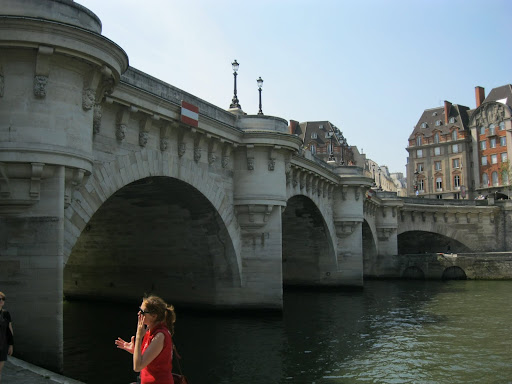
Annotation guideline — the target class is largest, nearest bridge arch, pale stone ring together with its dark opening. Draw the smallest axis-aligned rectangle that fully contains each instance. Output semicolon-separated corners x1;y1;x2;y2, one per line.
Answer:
64;150;241;304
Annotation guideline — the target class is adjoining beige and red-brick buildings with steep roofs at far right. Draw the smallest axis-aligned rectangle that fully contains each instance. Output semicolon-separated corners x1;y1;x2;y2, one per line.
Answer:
406;85;512;199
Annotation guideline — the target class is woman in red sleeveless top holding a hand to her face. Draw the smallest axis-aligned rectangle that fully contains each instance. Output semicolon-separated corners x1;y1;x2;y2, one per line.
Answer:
115;296;176;384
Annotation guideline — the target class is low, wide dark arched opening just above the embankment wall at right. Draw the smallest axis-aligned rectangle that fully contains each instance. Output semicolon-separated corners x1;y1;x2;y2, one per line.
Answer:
397;231;471;255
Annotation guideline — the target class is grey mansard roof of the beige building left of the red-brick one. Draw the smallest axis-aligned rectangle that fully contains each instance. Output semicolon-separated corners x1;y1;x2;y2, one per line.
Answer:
409;102;469;140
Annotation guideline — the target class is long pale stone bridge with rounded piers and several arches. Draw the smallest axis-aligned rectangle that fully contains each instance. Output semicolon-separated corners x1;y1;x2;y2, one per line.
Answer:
0;0;510;370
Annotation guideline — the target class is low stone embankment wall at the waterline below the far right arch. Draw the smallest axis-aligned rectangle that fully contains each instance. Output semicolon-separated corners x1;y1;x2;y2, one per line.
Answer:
365;252;512;280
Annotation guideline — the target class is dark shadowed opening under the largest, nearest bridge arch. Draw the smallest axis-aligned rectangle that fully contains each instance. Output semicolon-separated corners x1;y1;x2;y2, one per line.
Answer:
64;176;240;305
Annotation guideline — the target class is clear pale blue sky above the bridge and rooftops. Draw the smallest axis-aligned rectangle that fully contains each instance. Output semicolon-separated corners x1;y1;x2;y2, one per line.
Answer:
75;0;512;176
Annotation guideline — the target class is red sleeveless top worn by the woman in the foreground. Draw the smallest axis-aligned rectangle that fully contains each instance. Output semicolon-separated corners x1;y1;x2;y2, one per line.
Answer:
140;323;174;384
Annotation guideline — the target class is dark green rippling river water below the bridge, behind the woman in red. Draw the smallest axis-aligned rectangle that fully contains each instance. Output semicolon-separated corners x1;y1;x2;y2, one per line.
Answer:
64;281;512;384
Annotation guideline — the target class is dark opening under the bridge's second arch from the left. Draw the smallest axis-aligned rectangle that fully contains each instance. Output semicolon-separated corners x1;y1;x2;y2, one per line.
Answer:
282;195;337;286
